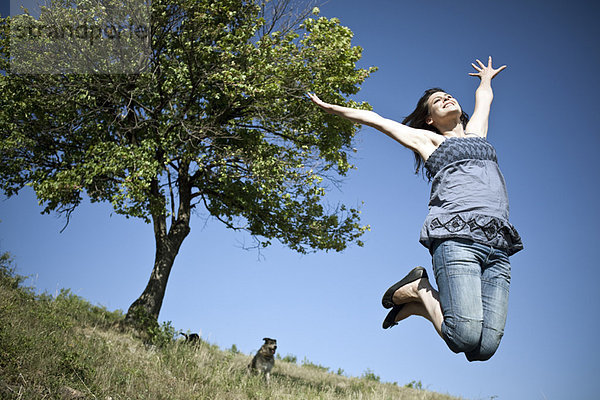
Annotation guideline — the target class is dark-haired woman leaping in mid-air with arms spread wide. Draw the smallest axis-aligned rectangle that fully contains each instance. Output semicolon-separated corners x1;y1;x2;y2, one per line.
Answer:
309;57;523;361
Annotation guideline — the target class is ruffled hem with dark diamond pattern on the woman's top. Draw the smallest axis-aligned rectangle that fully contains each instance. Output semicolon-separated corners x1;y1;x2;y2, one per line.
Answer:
419;213;523;255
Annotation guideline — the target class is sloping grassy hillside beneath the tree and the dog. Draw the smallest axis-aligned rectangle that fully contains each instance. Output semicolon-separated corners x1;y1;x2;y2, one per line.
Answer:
0;254;456;400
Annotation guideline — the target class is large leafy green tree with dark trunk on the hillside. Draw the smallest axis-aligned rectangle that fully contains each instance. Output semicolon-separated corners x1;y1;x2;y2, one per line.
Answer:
0;0;375;322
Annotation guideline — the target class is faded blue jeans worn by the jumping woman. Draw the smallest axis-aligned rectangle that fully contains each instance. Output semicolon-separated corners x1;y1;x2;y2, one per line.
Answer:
431;239;510;361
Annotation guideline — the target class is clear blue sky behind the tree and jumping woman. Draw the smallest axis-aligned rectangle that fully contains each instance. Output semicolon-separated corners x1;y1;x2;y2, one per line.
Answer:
0;0;600;400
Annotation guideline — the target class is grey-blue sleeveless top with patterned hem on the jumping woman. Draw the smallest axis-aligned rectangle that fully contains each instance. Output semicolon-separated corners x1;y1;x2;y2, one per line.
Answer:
419;137;523;255
